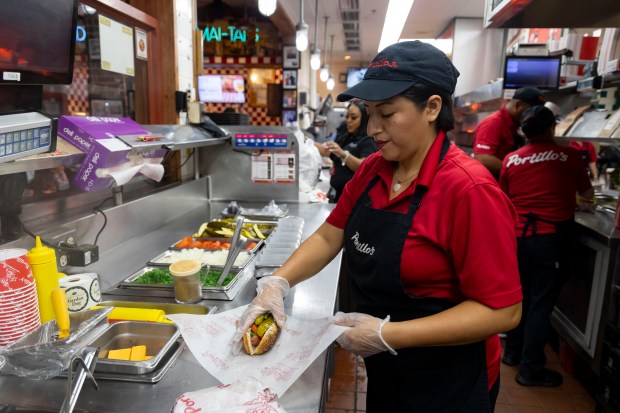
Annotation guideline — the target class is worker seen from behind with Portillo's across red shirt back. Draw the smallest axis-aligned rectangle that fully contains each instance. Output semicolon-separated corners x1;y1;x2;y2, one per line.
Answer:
500;106;594;387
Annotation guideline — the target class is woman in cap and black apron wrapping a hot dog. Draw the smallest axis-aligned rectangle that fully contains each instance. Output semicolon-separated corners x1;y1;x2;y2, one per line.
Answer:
233;41;521;413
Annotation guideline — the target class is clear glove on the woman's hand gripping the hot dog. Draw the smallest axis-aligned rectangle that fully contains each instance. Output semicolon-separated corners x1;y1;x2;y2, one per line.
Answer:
231;275;291;354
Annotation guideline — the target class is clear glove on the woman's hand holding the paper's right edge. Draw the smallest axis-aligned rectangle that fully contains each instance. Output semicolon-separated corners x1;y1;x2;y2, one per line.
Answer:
332;312;396;357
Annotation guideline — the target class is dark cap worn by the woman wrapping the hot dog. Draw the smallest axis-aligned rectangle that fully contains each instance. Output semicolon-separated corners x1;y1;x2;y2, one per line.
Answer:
338;40;459;102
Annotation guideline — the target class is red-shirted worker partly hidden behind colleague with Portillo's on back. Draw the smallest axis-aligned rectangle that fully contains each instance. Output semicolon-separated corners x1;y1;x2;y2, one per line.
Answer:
474;86;545;178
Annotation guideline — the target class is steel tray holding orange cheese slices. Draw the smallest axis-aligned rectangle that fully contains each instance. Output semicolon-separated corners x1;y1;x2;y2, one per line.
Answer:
90;321;181;375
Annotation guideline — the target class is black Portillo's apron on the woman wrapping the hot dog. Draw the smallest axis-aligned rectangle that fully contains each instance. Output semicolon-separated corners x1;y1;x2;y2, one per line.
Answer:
344;138;491;413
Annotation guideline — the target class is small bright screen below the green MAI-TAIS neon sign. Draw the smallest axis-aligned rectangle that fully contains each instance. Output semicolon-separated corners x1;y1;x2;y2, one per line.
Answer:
198;75;245;103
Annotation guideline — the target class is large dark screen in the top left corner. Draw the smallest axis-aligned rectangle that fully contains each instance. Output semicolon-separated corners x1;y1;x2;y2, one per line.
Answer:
0;0;78;85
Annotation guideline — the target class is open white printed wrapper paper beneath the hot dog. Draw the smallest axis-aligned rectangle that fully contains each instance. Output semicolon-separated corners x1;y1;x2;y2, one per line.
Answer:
166;305;349;396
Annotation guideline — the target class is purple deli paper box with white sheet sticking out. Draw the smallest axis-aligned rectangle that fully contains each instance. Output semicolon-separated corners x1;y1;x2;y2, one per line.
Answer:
58;116;166;192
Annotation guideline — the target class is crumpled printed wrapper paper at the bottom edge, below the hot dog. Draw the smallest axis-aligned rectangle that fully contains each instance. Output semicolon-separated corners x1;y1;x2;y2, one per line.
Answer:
172;379;286;413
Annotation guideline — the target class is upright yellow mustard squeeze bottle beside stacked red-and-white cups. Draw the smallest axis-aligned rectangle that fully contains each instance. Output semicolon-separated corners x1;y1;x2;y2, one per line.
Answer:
28;236;60;324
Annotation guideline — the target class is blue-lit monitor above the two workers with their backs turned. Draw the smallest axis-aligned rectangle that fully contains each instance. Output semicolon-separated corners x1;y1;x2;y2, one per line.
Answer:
504;56;562;90
